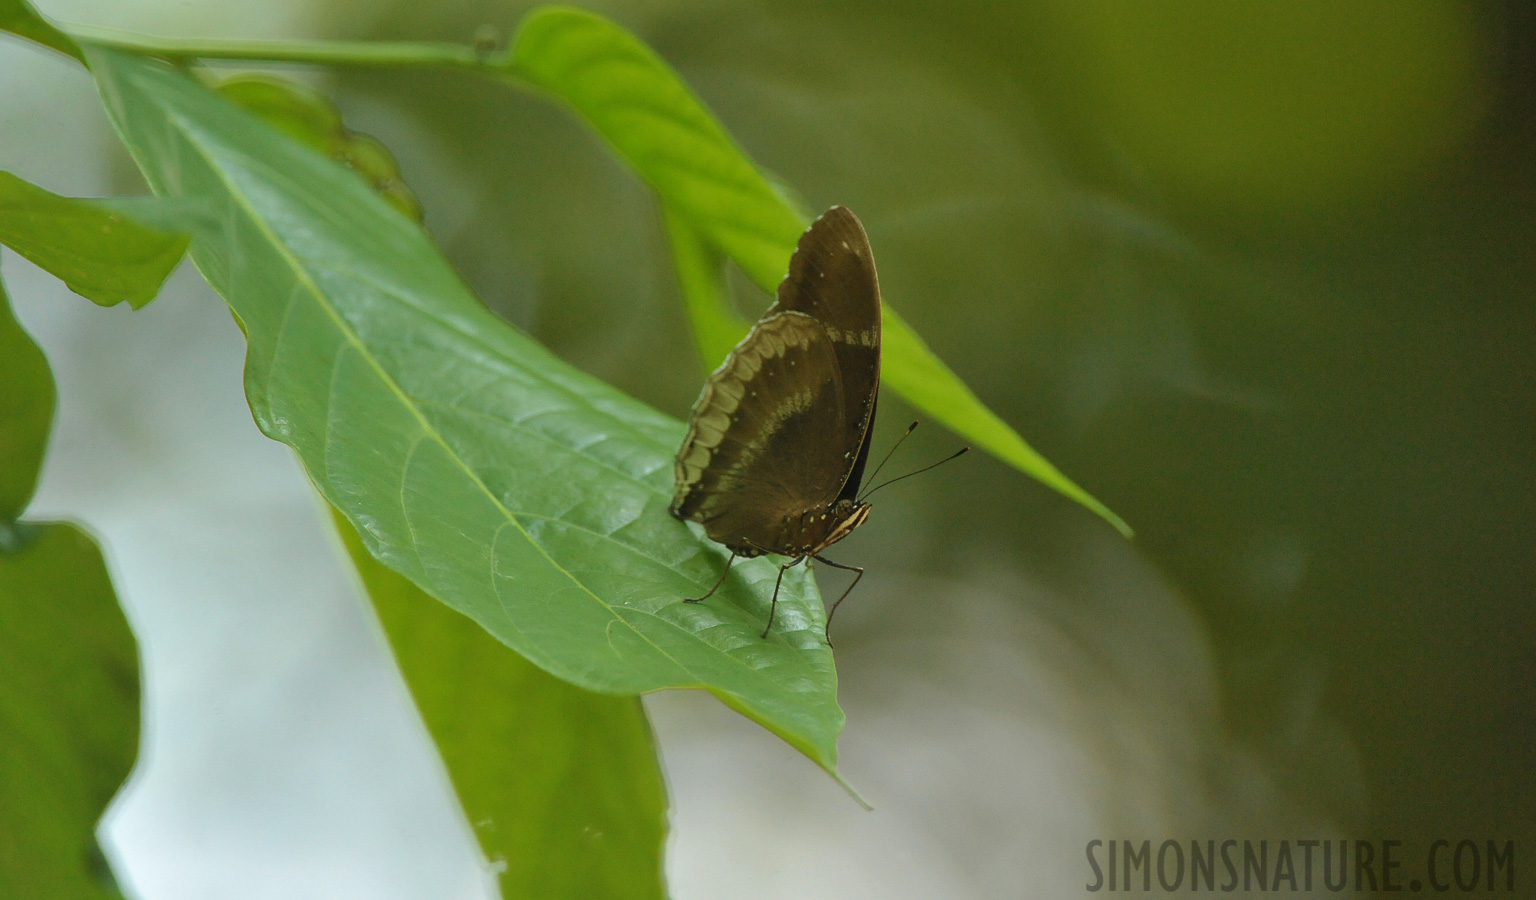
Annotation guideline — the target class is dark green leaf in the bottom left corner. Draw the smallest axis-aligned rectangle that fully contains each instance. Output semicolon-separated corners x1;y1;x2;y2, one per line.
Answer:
0;522;138;900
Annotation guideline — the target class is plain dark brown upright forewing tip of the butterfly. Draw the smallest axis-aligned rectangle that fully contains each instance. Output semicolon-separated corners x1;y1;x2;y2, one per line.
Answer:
766;206;880;499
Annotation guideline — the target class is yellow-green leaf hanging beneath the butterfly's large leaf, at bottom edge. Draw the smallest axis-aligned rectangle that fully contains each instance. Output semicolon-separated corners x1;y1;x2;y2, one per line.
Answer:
336;515;667;900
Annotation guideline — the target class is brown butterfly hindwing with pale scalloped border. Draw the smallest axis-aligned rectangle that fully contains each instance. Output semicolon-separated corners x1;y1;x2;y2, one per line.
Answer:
671;312;849;553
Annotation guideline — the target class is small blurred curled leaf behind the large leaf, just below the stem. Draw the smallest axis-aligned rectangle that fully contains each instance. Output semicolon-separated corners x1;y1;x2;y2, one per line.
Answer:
214;75;421;221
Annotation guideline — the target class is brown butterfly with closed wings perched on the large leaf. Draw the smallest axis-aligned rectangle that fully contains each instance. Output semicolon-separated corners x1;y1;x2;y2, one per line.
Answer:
671;206;880;637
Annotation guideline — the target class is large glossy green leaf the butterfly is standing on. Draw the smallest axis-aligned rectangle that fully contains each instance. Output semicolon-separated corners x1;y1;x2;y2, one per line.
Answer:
86;48;843;771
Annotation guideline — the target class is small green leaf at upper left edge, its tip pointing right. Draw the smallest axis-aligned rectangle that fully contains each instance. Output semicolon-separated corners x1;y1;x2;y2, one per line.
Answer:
0;172;187;309
